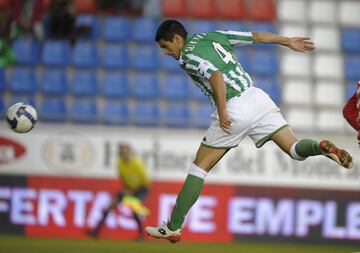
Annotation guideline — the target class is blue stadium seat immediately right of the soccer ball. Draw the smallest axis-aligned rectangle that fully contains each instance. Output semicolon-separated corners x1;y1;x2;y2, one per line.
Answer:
39;97;67;122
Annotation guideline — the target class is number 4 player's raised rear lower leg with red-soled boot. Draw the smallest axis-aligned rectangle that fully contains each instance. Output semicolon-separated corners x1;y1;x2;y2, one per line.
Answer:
272;127;352;168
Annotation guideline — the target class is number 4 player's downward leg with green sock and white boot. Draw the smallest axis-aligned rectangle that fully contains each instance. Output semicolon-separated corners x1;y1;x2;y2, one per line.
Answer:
145;145;229;242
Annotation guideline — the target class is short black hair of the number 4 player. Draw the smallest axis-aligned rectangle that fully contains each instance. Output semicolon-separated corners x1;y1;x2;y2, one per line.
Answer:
155;19;188;42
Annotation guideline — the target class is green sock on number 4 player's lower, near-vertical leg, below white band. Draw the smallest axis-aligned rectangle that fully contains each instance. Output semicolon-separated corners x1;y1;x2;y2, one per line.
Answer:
167;174;204;231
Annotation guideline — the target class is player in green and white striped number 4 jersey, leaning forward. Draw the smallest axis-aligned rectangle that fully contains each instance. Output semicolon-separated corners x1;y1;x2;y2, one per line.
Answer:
145;20;352;242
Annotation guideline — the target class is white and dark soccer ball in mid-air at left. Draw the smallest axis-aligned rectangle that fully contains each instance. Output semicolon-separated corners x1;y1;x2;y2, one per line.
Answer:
6;103;37;133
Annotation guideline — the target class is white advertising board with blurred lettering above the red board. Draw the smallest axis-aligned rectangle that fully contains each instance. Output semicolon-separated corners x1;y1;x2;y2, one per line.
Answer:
0;124;360;190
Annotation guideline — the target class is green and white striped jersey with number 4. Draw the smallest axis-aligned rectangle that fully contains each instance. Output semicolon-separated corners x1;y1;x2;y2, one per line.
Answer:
179;30;253;105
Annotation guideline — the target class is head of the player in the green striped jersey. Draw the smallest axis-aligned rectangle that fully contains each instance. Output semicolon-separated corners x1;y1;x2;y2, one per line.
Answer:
155;19;188;60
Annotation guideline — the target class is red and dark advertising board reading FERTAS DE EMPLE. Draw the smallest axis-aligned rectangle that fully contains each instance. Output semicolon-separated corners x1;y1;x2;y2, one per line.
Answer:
0;176;360;242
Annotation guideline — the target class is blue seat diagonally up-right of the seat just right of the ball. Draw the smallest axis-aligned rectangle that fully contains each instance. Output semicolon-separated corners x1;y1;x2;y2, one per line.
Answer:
70;70;98;96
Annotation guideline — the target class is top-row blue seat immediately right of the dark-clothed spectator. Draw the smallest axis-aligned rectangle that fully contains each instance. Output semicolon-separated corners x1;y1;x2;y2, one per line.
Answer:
103;16;130;42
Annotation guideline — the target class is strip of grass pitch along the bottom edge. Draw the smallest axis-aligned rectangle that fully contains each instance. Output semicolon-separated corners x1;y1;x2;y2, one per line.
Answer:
0;236;360;253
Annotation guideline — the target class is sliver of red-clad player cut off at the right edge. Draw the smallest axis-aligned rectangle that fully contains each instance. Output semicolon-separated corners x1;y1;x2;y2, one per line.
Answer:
343;81;360;146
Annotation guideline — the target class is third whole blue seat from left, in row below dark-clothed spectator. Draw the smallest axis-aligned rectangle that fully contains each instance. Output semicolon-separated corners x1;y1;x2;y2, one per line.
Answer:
72;41;98;68
